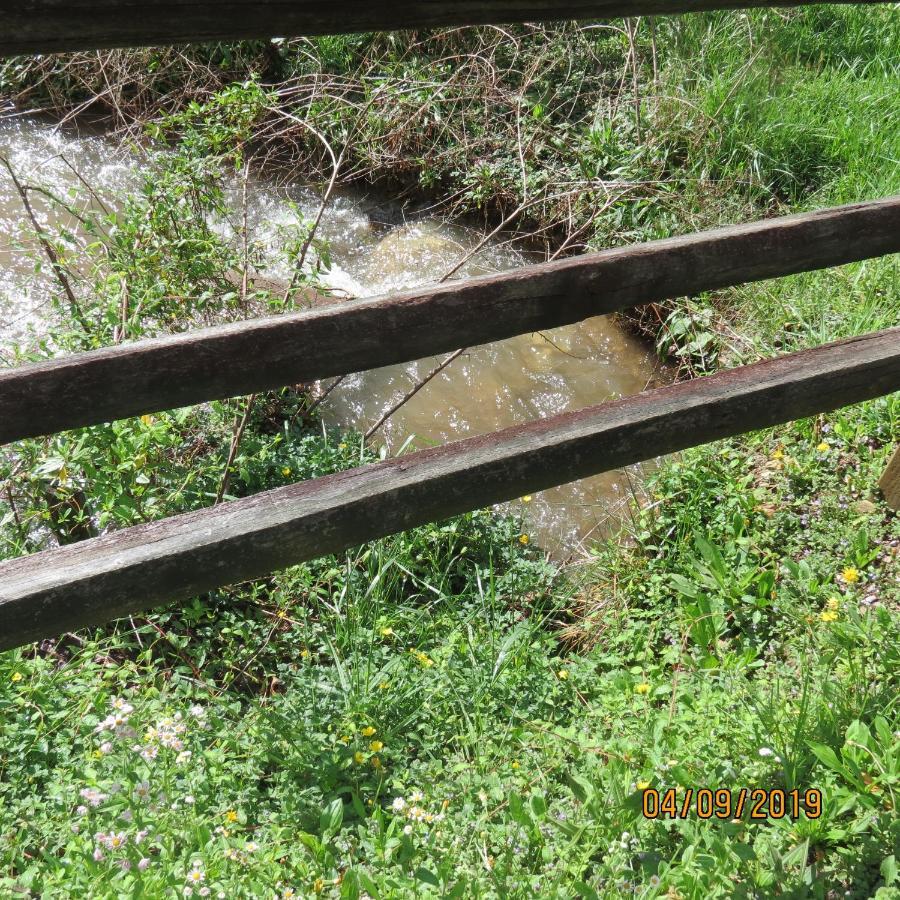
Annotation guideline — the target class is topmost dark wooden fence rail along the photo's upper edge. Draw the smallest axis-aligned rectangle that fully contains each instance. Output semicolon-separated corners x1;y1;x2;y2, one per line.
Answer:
0;0;887;55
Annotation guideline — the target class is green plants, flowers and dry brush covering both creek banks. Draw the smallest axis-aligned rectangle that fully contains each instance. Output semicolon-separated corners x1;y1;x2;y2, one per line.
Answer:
0;6;900;898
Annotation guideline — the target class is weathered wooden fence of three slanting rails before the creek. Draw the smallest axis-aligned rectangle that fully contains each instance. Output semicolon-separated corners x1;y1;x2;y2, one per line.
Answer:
0;0;900;650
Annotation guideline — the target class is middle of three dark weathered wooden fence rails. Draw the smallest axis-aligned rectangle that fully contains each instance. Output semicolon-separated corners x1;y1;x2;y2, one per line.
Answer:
0;196;900;443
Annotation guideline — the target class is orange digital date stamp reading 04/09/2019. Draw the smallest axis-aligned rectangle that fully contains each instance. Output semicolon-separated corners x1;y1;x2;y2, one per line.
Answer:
643;788;822;821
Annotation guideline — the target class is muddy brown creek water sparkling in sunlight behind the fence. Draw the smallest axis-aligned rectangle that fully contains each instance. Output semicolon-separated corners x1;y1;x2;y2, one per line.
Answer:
0;117;660;556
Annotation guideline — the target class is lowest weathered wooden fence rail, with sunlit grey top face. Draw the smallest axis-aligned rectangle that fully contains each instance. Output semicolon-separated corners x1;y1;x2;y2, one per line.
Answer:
0;328;900;650
